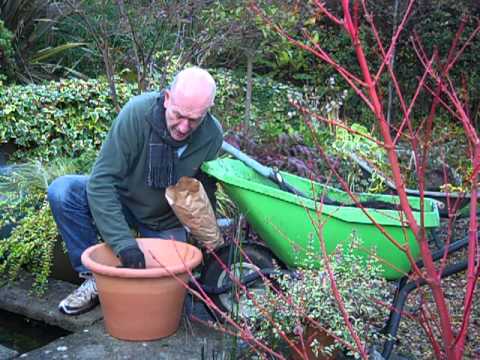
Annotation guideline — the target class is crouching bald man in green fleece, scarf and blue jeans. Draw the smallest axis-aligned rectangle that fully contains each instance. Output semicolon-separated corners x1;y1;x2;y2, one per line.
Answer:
48;67;222;315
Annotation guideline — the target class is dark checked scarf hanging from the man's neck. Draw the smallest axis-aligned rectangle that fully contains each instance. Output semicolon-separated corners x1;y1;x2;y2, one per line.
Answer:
145;93;191;189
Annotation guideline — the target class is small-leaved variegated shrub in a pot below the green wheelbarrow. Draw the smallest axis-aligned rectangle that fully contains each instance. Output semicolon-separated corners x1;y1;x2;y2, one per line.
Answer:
244;237;390;359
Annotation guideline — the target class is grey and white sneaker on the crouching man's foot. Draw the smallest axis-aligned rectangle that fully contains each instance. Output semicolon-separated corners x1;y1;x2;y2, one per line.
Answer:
58;275;99;315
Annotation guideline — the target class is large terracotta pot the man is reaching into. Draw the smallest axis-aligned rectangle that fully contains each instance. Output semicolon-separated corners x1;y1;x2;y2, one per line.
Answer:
82;238;202;341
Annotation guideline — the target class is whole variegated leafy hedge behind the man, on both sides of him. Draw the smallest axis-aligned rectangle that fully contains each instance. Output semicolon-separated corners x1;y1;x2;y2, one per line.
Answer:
0;69;316;160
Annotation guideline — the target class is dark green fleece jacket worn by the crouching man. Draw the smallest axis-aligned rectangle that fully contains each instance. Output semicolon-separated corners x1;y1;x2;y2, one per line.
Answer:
87;92;223;254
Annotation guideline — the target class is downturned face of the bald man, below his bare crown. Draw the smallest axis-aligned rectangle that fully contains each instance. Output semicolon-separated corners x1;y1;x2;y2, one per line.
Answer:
164;90;209;141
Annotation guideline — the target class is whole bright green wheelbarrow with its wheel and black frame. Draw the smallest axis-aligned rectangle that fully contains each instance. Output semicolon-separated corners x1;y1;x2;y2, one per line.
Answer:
189;145;468;359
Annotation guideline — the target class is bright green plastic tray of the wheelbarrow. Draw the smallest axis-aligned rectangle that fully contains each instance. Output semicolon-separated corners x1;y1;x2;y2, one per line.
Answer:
202;159;440;279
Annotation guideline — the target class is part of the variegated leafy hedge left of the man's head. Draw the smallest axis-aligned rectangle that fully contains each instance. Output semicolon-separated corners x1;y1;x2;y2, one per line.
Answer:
0;80;133;160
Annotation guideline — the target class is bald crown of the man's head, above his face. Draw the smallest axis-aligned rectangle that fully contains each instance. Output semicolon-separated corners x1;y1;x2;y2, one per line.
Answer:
170;66;216;107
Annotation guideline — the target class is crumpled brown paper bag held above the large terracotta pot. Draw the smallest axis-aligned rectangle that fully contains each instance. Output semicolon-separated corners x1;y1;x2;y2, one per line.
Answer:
165;176;224;251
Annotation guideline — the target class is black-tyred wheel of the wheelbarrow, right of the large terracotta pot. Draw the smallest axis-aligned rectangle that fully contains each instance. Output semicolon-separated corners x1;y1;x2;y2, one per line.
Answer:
201;244;278;316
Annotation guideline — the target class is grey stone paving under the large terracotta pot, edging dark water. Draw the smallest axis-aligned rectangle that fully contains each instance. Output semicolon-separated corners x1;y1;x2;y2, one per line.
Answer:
0;275;228;360
